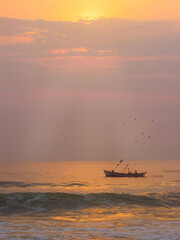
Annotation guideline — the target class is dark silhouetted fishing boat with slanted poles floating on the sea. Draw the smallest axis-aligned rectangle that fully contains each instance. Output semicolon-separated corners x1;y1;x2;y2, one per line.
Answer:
104;160;146;178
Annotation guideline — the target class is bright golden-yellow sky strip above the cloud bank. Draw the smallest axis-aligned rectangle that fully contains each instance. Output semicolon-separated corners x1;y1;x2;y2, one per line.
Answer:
0;0;180;21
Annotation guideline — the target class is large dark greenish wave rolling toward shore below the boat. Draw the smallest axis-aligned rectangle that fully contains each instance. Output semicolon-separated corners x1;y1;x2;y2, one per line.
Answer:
0;192;180;214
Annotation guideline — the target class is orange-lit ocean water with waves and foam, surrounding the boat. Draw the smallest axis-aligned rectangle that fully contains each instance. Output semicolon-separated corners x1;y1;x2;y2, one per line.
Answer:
0;161;180;240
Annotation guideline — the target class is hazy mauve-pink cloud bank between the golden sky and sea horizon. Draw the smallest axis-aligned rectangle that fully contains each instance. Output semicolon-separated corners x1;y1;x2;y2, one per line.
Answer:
0;18;180;160
